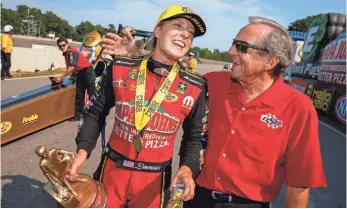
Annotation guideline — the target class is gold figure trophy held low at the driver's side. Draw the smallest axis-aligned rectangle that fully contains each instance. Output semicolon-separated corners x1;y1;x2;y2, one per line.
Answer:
35;146;107;208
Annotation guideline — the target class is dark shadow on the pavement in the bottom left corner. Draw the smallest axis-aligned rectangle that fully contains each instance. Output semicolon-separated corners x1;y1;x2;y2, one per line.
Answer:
1;175;57;208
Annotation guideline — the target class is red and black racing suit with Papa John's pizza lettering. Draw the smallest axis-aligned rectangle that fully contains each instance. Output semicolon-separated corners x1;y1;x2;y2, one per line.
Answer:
76;57;207;208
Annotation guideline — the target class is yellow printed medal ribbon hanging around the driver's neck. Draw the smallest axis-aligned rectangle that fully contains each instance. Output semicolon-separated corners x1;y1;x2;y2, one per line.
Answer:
135;54;179;131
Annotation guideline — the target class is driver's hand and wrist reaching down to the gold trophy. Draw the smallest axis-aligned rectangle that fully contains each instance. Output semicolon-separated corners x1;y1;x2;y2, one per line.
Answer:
65;149;88;182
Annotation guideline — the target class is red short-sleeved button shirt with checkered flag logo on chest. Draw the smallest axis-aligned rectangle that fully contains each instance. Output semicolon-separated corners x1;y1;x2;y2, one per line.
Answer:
197;72;327;202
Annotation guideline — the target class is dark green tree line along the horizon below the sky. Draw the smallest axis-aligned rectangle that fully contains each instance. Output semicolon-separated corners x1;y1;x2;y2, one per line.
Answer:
1;5;315;62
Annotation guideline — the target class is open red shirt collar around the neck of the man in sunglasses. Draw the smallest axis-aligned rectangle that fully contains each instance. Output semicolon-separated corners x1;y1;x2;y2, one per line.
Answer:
228;76;288;107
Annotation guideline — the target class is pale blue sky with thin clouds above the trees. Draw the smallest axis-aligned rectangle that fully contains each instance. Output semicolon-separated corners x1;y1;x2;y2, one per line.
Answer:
2;0;346;51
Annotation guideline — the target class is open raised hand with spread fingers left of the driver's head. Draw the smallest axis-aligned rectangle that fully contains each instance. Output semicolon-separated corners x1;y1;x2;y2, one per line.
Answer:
101;27;138;56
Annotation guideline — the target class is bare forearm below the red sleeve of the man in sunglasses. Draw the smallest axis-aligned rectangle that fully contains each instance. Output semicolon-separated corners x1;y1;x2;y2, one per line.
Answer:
285;186;310;208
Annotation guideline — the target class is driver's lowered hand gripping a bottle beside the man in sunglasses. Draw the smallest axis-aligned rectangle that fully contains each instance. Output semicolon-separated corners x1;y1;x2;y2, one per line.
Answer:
170;166;195;201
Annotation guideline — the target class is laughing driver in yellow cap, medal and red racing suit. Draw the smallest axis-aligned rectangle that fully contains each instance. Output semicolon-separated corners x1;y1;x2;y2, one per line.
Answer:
67;5;208;208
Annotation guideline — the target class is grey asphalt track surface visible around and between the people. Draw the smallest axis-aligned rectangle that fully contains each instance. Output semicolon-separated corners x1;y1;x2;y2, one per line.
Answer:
1;65;346;208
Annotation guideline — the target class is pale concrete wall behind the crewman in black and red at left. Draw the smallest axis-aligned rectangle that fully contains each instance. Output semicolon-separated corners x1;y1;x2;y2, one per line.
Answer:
11;47;66;72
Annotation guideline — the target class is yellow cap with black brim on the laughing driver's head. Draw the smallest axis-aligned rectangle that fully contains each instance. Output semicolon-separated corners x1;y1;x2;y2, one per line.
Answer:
156;5;206;37
